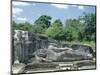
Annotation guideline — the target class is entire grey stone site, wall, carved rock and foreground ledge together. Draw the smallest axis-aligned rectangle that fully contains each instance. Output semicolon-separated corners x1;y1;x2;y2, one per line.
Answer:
12;30;95;74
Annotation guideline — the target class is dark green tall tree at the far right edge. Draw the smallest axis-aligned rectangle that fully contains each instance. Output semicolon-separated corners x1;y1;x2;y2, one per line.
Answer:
80;13;96;41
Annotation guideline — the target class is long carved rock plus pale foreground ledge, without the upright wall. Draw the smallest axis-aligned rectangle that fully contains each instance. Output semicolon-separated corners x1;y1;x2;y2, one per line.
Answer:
12;45;96;73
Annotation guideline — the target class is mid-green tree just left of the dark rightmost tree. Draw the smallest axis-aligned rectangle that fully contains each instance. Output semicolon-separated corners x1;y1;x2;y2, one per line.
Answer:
65;19;82;41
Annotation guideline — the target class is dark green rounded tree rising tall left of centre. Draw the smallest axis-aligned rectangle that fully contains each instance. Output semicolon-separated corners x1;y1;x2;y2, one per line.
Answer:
34;15;51;33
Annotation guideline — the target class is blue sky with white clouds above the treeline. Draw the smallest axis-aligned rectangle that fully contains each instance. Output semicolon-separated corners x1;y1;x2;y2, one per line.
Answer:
12;1;95;24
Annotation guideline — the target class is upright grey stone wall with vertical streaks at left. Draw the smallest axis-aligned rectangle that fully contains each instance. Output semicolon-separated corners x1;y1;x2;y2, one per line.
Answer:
12;30;48;63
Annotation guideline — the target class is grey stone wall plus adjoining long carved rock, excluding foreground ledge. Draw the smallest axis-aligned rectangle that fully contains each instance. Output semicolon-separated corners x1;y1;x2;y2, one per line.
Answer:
13;30;93;63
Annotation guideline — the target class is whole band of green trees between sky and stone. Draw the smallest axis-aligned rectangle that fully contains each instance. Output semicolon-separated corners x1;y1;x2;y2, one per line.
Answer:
12;13;96;42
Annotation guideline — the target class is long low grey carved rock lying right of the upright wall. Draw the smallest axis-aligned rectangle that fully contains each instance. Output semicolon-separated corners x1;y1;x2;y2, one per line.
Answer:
34;45;93;62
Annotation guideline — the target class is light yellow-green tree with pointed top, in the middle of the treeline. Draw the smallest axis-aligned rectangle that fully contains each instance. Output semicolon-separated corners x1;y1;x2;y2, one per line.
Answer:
46;20;66;41
